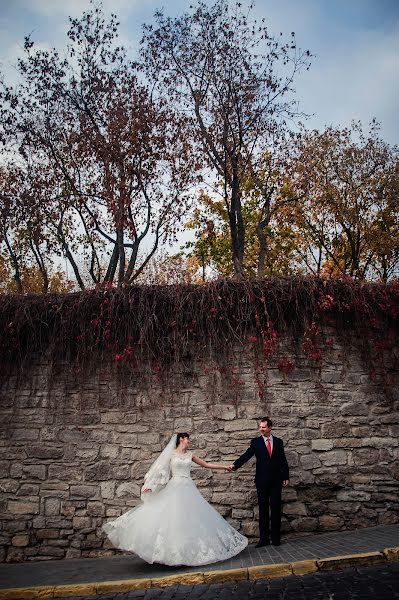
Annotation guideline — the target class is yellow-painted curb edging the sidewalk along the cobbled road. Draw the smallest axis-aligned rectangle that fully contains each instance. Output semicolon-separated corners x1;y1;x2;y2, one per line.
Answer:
0;547;399;600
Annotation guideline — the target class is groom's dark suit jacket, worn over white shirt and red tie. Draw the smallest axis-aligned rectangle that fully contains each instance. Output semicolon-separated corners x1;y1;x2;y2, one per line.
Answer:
233;435;289;487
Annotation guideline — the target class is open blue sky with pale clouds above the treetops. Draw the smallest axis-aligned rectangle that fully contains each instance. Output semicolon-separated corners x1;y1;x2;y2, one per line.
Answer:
0;0;399;144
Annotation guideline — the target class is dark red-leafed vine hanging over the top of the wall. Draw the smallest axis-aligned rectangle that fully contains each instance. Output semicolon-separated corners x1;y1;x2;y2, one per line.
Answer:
0;278;399;397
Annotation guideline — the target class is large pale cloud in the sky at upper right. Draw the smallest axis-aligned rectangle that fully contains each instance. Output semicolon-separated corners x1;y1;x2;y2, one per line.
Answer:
297;17;399;143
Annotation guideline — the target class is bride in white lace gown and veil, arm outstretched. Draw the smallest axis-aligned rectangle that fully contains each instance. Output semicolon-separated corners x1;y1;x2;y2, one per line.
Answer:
102;433;248;566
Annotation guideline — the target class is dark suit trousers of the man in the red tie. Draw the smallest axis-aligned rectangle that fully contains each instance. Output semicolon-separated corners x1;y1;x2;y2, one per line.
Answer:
256;481;282;542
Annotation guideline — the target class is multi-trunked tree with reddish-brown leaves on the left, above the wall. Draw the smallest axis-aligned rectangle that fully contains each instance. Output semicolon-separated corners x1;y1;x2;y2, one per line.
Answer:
0;5;195;288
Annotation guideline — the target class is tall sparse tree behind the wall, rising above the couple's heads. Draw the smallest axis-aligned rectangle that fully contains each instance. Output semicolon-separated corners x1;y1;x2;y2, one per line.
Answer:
142;0;310;276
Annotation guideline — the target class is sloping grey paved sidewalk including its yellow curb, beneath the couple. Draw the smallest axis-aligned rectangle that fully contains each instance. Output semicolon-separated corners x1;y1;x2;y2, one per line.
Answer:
0;524;399;598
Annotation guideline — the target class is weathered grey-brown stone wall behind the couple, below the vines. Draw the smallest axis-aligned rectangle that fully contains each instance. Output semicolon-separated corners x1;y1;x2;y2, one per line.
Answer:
0;338;399;561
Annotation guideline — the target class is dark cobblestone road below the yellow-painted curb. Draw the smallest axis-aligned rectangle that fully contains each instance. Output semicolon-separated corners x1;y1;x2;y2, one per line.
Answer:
55;562;399;600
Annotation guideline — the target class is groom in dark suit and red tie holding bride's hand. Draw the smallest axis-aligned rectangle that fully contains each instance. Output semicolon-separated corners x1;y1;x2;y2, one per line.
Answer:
229;417;289;548
